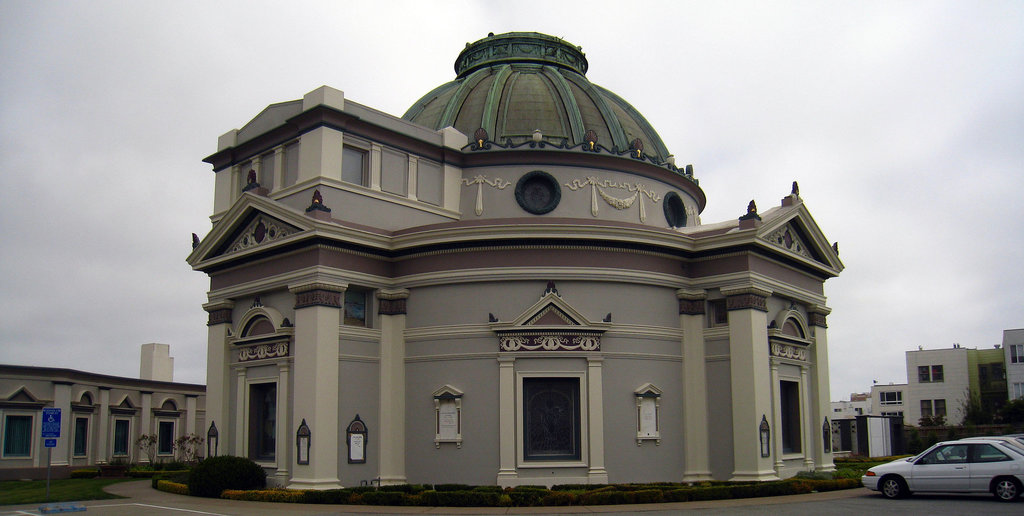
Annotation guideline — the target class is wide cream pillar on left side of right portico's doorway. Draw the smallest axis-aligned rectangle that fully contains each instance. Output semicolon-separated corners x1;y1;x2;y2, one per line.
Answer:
722;287;779;481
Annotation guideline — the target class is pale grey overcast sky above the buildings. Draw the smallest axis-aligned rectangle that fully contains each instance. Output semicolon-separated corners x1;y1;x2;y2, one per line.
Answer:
0;0;1024;399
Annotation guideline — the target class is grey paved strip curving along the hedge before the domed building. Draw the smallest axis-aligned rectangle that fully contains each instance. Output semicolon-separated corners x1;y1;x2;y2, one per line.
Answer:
0;480;870;516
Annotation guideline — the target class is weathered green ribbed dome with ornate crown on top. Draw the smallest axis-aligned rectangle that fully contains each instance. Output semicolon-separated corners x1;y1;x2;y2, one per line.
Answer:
402;33;669;163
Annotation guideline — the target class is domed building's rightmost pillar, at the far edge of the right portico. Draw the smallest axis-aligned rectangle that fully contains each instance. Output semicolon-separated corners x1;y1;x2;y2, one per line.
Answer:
808;305;836;471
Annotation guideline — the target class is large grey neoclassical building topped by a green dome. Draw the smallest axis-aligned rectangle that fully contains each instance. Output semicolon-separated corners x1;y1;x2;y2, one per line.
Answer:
188;33;843;488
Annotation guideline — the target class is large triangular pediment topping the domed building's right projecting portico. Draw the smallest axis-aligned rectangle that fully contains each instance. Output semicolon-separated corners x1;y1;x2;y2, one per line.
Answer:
757;202;844;274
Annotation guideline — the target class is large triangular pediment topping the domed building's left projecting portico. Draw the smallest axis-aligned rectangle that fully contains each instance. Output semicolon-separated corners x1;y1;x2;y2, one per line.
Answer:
187;194;314;267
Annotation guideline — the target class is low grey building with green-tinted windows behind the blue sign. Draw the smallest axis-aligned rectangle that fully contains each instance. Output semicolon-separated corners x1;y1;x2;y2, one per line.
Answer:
0;344;206;479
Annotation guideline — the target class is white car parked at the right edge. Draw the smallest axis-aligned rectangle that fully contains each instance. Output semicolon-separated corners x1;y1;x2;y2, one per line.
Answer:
860;439;1024;502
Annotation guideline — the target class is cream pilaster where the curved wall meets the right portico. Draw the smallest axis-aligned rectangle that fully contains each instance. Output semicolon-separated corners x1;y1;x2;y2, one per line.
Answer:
676;290;712;482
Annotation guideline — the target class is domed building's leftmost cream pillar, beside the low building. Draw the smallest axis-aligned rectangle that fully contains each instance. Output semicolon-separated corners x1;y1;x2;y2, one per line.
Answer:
200;299;232;455
